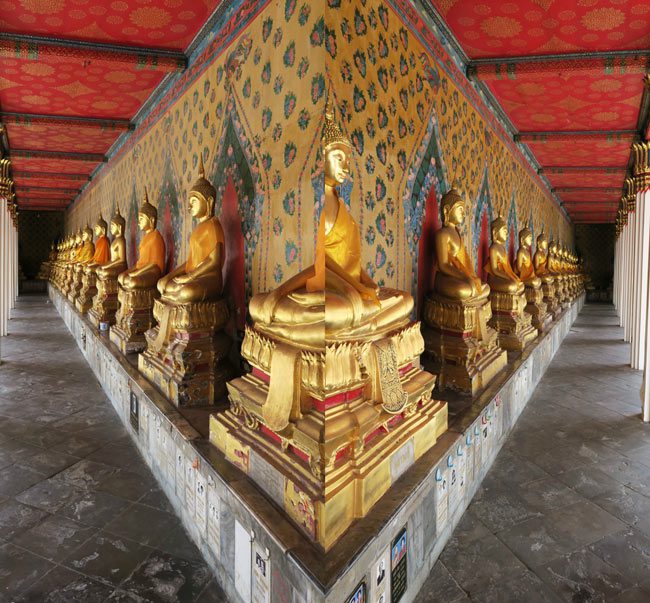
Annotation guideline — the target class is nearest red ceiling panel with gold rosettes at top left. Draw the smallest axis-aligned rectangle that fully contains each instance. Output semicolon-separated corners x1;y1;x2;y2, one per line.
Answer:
0;0;219;50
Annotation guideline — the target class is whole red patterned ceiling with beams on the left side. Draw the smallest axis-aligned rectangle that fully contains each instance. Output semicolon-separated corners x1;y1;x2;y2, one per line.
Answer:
0;0;223;207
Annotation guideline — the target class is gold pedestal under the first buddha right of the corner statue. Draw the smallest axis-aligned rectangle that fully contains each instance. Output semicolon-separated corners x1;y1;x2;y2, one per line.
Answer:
422;293;508;395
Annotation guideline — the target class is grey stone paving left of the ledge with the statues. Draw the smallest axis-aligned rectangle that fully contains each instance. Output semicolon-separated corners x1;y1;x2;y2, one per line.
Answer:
0;296;226;603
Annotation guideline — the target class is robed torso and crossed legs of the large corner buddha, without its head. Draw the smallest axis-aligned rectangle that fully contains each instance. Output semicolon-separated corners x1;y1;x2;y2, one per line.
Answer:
249;199;413;347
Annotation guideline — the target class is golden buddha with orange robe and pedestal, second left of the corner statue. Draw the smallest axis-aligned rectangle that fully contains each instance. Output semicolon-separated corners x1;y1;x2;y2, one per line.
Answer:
110;189;165;354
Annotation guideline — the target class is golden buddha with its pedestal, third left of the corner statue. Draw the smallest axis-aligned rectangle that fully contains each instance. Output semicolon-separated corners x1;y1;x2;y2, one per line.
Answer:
88;206;128;331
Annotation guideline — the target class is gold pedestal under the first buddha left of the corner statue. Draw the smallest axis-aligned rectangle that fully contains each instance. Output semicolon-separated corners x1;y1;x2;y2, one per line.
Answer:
138;299;232;406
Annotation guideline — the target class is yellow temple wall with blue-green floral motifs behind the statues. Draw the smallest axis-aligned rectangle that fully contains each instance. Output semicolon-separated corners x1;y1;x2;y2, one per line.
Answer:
66;0;573;316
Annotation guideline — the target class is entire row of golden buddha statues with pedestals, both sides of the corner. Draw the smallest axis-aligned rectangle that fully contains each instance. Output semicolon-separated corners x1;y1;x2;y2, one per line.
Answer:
45;105;581;550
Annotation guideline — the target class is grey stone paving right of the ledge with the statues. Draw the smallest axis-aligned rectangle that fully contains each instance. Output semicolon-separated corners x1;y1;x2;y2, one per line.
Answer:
416;304;650;603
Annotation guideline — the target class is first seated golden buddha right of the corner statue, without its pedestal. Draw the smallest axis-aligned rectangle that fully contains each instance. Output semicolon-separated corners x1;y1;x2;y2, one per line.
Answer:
433;188;490;301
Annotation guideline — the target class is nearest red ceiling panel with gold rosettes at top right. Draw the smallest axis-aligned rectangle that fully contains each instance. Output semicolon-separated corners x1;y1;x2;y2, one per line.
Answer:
433;0;650;58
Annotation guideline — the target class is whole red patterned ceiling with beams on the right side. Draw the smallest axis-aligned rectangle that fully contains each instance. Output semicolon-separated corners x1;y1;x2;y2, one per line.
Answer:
433;0;650;222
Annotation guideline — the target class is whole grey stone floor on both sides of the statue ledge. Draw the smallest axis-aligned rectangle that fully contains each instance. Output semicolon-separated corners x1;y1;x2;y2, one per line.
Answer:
0;297;650;603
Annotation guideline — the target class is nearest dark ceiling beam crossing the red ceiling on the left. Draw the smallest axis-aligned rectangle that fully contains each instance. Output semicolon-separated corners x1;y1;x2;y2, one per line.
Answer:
0;33;187;73
